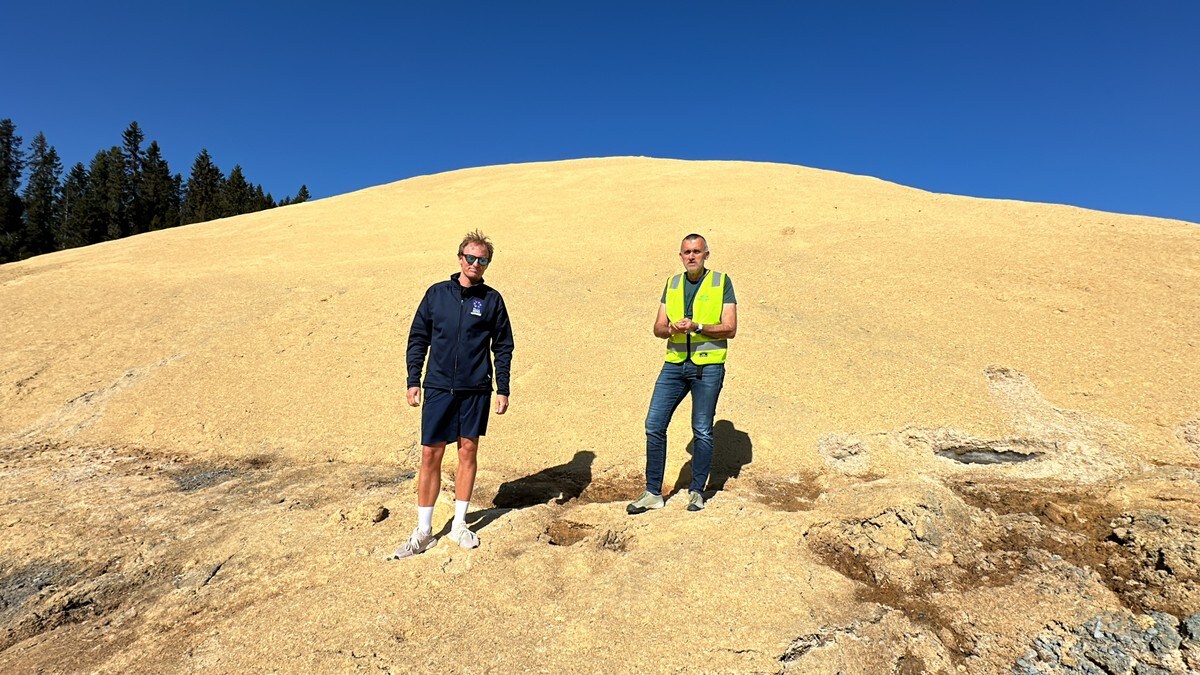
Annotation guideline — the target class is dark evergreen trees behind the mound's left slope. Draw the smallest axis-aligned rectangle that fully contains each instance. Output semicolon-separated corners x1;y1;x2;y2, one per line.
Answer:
0;119;308;263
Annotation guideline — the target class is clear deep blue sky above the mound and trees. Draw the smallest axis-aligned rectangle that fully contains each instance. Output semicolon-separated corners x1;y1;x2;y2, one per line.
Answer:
0;0;1200;222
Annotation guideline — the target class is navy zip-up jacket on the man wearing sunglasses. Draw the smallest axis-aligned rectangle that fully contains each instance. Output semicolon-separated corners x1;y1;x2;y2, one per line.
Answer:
408;273;512;396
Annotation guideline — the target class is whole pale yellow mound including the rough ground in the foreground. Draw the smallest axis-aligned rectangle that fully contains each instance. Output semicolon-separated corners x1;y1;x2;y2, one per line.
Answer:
0;159;1200;673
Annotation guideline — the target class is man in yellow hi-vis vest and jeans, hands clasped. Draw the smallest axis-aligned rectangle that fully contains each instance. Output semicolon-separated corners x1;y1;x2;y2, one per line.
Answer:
625;234;738;514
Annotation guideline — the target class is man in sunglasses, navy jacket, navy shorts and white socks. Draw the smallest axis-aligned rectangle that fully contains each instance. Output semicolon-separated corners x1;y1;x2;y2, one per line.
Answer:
394;231;512;557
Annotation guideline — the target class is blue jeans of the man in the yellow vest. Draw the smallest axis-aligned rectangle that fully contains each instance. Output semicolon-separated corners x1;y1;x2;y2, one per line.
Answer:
646;362;725;495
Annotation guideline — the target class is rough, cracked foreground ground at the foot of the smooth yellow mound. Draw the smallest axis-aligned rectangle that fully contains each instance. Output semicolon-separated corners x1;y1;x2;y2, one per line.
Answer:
0;427;1200;673
